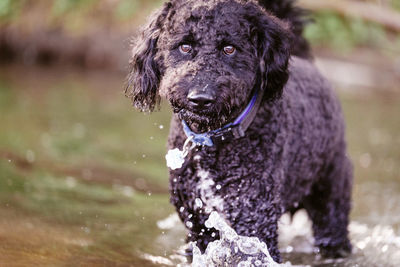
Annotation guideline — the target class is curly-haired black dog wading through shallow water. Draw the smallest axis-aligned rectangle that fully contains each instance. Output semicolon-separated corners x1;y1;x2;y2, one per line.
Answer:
126;0;352;262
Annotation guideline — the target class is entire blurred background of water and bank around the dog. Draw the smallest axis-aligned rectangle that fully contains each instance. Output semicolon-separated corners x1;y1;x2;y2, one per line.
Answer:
0;0;400;266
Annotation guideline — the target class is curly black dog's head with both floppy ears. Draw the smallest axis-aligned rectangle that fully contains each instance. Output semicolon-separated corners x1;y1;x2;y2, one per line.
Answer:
126;0;290;132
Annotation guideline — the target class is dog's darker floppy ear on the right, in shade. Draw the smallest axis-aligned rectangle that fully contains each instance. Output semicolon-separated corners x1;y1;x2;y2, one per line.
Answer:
255;15;290;99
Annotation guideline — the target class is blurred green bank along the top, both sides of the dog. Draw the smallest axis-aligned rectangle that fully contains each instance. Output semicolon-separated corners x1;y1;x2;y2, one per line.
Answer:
0;0;400;56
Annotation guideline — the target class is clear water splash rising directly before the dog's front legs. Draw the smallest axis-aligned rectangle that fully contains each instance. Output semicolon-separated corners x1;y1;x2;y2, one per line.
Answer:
191;211;293;267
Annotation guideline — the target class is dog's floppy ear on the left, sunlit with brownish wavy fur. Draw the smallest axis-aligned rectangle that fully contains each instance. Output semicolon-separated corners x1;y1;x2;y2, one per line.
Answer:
125;3;171;111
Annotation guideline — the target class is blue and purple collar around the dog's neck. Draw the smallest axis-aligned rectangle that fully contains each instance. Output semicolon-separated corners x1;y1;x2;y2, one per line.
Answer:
182;86;263;147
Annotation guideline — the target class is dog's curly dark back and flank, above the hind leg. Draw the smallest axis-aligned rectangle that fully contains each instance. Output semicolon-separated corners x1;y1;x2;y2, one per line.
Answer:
274;57;351;210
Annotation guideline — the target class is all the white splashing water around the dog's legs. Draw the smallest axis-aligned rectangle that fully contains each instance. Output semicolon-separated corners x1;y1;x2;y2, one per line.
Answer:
157;209;400;267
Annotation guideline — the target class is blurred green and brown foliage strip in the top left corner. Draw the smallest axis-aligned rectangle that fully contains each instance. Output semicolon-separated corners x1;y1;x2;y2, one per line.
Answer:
0;0;163;34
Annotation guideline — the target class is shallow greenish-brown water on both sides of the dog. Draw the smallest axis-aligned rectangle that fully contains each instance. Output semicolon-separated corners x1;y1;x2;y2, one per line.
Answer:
0;66;400;266
